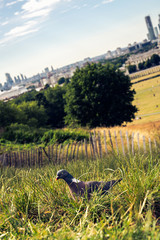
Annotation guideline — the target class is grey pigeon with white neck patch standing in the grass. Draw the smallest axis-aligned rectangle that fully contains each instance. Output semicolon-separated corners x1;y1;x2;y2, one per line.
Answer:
56;169;122;200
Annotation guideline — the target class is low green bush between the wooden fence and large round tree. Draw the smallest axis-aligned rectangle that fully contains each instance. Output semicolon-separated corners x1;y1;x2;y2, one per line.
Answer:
41;129;89;144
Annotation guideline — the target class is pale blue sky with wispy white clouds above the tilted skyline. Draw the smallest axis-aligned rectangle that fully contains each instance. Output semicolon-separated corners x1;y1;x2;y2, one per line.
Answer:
0;0;160;82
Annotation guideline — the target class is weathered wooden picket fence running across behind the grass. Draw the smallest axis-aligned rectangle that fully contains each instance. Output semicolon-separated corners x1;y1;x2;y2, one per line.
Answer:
0;130;159;167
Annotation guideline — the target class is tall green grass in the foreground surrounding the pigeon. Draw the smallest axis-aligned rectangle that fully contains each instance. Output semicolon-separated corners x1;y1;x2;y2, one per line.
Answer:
0;155;160;240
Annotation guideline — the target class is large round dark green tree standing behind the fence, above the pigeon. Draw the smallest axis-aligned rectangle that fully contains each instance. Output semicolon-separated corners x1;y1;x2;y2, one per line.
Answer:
65;63;137;127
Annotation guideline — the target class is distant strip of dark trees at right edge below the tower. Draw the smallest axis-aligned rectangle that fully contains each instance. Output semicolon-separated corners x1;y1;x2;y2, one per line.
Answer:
128;54;160;73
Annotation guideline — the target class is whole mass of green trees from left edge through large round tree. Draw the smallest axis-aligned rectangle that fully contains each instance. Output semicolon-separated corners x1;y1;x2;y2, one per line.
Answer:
0;63;137;142
